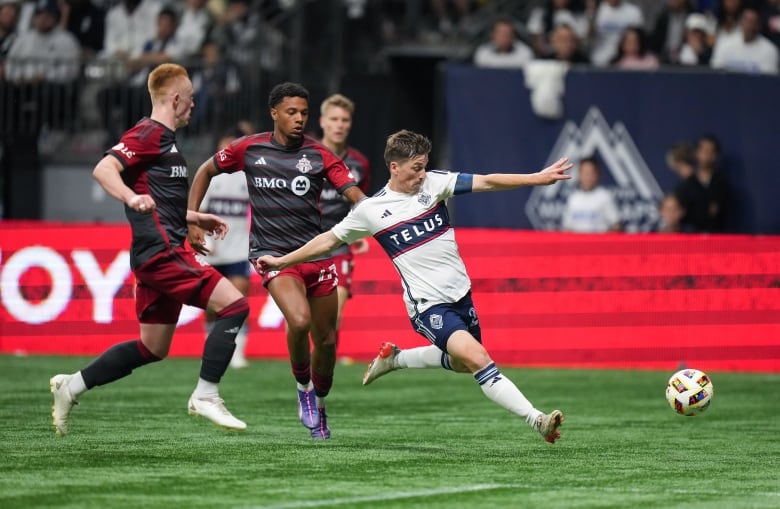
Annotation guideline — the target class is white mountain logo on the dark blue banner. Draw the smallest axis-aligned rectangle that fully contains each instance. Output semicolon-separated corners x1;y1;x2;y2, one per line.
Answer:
525;106;663;232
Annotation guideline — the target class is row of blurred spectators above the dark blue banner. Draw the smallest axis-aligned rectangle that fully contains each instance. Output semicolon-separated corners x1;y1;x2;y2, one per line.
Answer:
474;0;780;74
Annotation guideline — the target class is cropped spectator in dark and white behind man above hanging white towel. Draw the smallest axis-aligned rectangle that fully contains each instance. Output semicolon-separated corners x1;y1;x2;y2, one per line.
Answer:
526;0;588;57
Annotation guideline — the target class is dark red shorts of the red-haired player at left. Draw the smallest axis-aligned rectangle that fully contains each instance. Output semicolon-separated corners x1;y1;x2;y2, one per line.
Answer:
133;246;222;323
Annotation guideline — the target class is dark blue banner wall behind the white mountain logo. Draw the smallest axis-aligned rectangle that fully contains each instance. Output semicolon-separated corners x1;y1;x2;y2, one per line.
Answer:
445;64;780;234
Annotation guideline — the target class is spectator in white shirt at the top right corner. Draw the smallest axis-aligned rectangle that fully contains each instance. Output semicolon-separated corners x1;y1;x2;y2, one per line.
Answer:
710;8;778;74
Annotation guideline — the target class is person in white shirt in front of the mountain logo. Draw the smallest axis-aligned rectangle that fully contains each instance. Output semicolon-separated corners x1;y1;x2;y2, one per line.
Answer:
561;157;623;233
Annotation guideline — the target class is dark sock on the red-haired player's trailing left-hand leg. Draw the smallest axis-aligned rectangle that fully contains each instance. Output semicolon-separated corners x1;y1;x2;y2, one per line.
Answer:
81;339;161;389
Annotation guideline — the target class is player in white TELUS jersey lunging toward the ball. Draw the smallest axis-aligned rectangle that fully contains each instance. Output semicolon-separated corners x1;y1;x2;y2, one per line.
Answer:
257;130;572;443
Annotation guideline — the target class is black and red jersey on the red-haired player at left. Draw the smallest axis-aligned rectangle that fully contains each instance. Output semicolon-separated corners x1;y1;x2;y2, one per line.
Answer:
106;118;189;269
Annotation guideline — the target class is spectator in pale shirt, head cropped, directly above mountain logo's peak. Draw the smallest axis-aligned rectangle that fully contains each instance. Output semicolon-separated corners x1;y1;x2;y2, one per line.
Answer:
589;0;645;67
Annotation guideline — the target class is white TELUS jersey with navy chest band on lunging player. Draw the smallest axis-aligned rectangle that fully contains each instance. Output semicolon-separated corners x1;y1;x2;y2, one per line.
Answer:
331;170;471;317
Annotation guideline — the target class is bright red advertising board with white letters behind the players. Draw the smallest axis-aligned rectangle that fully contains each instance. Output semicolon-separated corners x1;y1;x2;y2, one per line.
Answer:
0;222;780;372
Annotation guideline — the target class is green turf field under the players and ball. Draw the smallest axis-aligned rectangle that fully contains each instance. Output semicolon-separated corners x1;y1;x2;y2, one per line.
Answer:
0;356;780;509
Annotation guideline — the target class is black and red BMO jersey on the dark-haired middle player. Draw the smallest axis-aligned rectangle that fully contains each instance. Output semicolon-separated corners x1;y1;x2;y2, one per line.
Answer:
214;132;356;258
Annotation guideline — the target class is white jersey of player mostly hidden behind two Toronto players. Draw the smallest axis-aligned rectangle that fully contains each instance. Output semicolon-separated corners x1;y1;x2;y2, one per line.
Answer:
200;171;249;265
